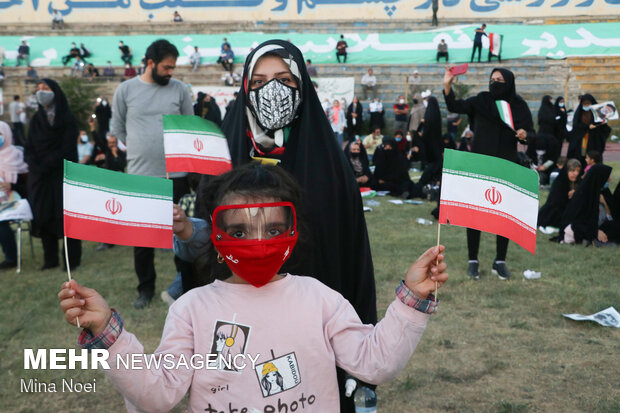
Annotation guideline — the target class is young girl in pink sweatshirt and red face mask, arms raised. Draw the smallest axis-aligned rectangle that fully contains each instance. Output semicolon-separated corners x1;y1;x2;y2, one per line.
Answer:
58;164;448;413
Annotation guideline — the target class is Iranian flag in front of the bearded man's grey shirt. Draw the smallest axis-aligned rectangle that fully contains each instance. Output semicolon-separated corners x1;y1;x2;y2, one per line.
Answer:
163;115;232;175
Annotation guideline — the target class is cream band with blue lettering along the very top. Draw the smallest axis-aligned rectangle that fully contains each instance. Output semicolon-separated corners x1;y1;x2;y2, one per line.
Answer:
0;0;618;23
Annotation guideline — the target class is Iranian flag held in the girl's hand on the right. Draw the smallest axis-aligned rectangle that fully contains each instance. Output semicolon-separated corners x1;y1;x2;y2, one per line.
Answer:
439;149;538;254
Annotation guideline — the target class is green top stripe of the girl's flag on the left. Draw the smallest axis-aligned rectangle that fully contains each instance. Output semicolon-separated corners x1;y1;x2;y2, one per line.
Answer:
64;160;172;200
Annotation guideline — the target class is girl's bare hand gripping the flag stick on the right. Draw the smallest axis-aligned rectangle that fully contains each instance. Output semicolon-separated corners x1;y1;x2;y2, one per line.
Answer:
405;245;448;300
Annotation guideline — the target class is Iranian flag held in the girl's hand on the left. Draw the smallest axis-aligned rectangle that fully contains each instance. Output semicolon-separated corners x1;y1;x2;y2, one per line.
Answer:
63;160;172;248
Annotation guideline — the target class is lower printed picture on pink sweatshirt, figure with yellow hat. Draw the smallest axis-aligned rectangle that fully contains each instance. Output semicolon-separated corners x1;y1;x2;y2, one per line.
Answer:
256;350;301;397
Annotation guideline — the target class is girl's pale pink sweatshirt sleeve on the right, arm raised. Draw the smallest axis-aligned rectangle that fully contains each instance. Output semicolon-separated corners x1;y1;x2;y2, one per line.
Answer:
324;299;429;384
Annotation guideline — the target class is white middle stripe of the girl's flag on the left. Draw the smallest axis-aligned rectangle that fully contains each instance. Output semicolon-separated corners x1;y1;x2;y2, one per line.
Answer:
63;183;172;226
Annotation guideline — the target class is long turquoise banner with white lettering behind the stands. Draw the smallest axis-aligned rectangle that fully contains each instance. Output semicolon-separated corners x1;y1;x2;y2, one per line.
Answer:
0;23;620;66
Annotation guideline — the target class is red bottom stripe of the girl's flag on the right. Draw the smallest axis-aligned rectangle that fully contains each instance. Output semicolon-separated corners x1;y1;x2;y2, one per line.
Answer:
439;201;536;254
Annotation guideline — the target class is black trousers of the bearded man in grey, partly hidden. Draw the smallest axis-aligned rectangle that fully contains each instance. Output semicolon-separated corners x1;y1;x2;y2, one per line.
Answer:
133;177;192;297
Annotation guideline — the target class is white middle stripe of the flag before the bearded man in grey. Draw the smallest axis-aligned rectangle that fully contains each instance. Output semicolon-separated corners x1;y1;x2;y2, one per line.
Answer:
164;131;230;160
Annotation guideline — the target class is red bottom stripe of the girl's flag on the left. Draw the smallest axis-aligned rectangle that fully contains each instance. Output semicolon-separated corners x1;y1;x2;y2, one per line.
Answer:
64;215;172;248
